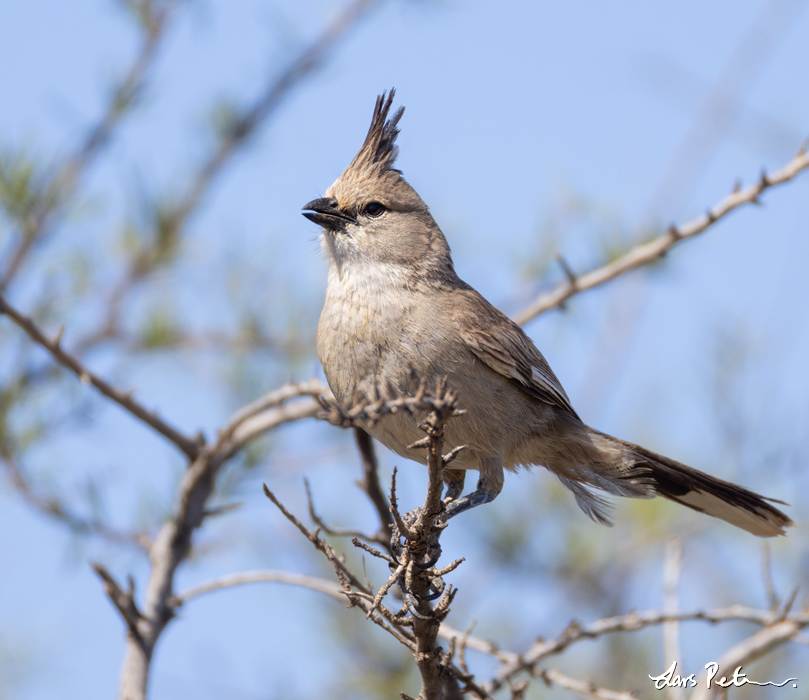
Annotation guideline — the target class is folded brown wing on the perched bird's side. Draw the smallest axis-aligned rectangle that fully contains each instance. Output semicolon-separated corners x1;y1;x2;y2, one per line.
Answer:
454;289;578;417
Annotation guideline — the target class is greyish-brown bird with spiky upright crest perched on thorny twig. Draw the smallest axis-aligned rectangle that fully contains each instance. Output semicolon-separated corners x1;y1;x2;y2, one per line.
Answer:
303;89;794;537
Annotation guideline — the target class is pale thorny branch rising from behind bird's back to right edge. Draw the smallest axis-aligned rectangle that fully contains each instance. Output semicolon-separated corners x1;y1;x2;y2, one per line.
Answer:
514;153;809;325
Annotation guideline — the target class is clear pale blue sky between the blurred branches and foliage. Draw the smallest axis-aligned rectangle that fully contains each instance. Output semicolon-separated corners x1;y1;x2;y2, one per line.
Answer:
0;0;809;700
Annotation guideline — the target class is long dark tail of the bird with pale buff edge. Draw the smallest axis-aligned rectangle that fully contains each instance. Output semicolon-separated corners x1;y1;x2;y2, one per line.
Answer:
589;428;795;537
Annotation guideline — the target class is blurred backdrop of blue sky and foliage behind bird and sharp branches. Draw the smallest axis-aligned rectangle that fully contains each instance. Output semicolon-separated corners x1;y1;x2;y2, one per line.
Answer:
0;0;809;700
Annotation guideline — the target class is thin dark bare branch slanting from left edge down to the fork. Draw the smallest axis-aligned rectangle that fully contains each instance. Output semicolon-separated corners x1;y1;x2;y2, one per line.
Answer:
0;296;202;459
